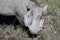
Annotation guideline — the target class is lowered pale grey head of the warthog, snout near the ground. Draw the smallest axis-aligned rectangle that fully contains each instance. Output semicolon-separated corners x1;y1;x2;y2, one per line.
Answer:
24;5;48;34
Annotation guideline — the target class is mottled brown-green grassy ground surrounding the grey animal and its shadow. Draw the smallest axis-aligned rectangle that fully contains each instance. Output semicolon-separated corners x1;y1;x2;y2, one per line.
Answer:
0;0;60;40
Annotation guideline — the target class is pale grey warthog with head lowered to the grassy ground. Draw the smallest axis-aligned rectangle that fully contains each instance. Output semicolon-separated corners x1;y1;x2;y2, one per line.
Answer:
0;0;48;34
